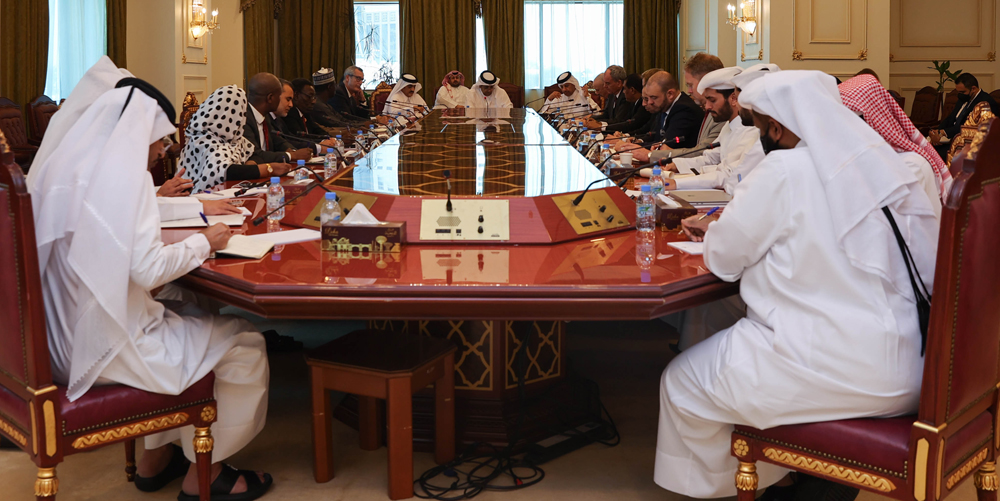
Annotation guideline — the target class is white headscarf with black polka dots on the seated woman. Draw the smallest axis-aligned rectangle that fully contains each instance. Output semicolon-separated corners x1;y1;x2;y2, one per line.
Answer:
178;85;253;191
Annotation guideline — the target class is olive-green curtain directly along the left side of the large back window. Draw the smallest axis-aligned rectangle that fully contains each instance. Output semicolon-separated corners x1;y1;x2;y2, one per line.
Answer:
482;0;524;87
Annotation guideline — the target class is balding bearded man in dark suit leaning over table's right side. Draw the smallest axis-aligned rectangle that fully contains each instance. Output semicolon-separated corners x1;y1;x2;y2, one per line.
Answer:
615;71;703;162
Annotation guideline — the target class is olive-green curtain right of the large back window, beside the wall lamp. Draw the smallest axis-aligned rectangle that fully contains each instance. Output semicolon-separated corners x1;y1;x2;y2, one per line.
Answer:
623;0;680;76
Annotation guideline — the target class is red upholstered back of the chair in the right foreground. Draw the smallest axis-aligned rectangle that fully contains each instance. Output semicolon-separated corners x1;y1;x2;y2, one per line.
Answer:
919;116;1000;430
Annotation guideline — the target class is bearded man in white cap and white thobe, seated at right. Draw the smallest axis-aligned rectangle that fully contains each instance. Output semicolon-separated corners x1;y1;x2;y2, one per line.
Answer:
649;66;764;194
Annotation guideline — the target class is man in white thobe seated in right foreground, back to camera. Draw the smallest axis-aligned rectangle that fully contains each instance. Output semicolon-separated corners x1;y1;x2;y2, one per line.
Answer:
654;71;939;498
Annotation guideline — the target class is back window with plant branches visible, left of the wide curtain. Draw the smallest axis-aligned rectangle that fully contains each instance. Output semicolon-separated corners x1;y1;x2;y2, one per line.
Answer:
352;0;400;89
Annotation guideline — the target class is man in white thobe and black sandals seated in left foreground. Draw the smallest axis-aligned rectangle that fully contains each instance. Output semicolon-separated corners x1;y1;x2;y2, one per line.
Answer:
29;72;271;500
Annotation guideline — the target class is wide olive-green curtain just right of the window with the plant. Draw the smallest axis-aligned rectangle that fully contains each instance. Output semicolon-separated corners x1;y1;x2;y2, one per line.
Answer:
397;0;474;105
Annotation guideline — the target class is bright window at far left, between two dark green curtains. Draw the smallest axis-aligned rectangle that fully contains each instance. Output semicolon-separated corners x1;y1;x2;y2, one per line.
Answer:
45;0;108;102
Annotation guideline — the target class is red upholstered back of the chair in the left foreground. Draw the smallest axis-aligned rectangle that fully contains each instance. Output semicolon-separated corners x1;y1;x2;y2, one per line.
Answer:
0;130;52;398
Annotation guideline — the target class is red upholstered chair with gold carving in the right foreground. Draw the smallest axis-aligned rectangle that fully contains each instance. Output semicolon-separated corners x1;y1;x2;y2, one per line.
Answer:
730;116;1000;501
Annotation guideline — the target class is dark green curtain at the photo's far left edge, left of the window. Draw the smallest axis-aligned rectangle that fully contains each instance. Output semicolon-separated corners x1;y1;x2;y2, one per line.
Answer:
0;0;49;108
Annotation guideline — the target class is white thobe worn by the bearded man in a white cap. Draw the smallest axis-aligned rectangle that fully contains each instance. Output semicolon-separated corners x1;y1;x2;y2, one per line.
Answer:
674;116;764;195
